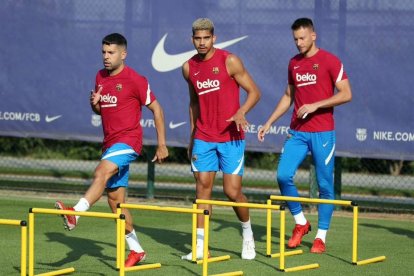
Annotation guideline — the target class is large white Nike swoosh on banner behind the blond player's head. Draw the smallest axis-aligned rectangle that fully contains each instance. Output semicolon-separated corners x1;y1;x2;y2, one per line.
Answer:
151;33;247;72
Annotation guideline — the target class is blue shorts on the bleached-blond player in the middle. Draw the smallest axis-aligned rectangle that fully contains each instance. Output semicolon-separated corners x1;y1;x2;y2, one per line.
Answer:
191;139;245;176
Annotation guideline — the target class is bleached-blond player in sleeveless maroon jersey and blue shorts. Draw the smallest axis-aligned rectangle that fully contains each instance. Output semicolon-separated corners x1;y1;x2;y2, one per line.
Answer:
182;18;260;260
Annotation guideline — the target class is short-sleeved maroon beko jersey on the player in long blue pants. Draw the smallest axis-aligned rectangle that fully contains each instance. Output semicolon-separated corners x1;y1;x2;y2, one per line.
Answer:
288;49;348;132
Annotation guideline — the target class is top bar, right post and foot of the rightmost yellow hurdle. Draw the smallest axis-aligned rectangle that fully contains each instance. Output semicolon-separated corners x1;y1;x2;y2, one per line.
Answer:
270;195;386;265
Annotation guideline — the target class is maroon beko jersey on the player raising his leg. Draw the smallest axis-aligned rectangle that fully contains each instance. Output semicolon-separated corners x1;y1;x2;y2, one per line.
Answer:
95;66;155;154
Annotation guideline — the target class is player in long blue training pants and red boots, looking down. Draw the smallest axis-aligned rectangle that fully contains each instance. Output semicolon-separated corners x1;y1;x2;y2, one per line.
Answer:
257;18;352;253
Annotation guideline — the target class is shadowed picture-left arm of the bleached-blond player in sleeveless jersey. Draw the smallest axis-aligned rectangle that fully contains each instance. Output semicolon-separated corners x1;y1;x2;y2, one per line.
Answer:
182;62;200;158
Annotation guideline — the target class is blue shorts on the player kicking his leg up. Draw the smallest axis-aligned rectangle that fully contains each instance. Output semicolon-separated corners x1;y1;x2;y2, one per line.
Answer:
101;143;138;188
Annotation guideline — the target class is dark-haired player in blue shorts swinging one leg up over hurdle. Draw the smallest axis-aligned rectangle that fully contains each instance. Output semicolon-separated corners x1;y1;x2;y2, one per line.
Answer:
55;33;168;267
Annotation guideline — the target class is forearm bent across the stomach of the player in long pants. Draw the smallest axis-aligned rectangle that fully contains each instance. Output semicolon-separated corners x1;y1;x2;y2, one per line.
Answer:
296;79;352;118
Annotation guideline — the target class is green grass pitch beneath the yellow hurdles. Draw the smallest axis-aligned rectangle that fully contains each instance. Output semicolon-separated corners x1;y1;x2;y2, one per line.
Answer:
0;194;414;275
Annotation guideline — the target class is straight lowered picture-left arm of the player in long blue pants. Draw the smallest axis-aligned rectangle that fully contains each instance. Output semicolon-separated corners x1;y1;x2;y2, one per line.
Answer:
257;85;295;142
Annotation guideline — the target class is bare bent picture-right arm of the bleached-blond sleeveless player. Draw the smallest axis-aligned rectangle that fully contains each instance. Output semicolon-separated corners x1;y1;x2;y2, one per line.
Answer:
226;55;260;130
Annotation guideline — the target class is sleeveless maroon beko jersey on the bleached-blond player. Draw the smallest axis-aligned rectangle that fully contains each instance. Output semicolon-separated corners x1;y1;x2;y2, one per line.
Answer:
188;49;244;142
